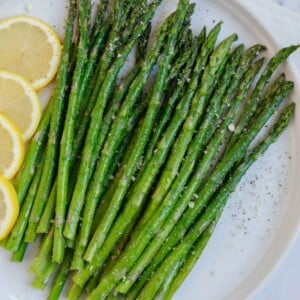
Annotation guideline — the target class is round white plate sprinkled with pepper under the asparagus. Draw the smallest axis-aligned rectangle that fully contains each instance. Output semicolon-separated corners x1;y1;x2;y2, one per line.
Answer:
0;0;300;300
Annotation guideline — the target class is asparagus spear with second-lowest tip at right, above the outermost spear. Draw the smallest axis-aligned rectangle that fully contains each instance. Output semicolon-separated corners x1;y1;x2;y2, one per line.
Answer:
133;78;293;292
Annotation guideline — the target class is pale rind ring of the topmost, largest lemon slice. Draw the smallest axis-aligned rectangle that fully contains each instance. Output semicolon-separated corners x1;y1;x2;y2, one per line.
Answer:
0;15;62;90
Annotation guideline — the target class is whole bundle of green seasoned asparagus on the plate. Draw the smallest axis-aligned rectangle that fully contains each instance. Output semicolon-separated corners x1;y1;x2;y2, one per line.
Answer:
4;0;298;300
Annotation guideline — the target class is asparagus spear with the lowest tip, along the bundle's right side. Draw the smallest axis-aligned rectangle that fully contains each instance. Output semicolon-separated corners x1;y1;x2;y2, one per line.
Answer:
139;101;294;300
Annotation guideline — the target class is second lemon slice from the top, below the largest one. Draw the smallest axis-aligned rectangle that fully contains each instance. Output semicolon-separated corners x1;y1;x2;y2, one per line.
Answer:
0;70;41;141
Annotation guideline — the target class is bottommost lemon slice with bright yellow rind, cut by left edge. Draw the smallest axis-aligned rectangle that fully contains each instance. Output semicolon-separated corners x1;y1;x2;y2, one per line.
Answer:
0;175;19;241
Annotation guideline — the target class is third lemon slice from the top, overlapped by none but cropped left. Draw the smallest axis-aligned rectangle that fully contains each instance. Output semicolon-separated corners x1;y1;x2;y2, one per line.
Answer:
0;114;25;179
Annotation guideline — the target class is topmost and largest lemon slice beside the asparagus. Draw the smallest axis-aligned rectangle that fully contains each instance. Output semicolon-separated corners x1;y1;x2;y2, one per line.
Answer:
0;16;61;89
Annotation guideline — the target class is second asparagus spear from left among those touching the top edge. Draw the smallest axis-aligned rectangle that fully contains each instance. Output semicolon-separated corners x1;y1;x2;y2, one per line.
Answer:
53;0;91;263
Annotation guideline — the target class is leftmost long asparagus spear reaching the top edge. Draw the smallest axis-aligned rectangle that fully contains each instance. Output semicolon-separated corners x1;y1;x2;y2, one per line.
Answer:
25;0;76;242
